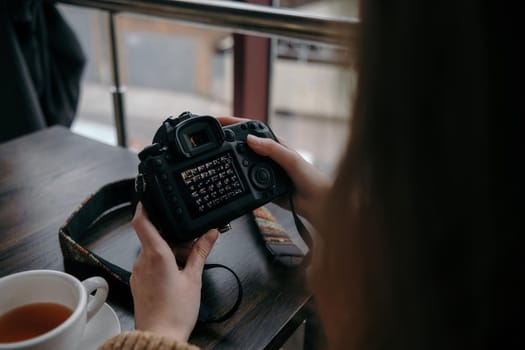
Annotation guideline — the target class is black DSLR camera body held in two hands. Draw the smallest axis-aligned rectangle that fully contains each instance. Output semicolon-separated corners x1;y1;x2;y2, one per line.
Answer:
135;112;292;242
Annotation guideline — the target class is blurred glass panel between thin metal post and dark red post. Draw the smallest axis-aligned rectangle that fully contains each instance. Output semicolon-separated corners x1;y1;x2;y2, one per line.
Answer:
117;14;233;150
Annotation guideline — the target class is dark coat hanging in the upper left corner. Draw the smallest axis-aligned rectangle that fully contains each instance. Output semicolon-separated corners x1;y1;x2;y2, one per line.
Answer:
0;0;85;142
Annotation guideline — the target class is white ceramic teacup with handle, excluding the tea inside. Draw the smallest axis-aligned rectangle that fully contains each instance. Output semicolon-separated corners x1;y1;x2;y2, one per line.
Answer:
0;270;108;350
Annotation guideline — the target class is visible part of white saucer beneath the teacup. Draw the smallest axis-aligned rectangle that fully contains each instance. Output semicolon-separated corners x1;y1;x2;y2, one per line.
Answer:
77;304;120;350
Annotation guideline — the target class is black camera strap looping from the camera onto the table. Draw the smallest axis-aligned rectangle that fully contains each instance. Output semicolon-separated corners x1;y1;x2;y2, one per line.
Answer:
59;178;313;323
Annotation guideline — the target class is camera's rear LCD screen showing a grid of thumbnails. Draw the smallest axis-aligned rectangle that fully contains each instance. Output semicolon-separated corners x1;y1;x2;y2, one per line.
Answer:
177;152;245;218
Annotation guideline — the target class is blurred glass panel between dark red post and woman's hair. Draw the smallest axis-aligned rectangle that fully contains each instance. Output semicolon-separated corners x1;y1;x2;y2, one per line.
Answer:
270;39;357;173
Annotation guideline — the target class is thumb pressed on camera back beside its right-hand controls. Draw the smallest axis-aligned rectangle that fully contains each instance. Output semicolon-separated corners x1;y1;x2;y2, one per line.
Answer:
246;135;306;180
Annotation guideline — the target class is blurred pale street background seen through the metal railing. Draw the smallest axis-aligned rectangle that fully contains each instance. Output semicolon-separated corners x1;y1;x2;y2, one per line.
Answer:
58;0;358;173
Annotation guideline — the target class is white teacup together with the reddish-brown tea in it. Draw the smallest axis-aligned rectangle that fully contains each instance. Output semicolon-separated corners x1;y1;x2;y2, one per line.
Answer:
0;270;108;350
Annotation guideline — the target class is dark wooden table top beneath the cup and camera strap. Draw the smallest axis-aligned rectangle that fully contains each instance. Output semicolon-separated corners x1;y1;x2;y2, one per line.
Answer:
0;127;316;349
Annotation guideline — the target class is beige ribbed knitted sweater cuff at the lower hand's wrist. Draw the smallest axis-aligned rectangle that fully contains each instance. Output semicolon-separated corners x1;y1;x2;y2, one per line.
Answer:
99;331;199;350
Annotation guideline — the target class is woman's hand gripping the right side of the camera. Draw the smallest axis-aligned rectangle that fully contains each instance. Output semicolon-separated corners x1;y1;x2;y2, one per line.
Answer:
217;117;331;226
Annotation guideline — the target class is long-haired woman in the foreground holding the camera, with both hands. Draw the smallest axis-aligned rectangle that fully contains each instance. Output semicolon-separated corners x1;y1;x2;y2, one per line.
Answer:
100;0;525;349
